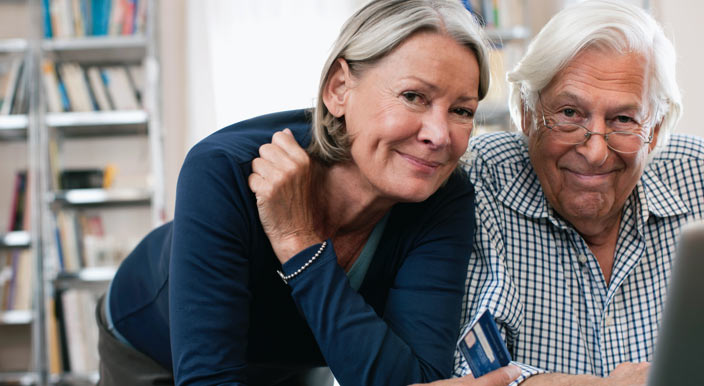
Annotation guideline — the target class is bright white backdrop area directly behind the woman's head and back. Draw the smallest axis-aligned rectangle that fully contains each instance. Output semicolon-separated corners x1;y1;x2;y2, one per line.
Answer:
187;0;356;145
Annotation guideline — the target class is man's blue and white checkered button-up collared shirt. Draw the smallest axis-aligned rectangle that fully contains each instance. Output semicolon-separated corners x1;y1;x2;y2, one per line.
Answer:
455;133;704;383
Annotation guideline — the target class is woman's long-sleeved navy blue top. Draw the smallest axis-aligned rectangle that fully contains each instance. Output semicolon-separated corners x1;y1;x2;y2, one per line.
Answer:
109;110;474;386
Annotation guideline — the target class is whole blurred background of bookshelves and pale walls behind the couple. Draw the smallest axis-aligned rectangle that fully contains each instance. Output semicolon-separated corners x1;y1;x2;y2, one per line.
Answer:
0;0;704;385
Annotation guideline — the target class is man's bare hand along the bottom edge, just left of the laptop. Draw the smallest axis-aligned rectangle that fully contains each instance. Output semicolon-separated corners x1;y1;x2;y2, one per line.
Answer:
521;362;650;386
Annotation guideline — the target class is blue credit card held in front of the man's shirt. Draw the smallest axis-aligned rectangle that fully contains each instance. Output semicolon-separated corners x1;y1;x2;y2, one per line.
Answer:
458;310;511;378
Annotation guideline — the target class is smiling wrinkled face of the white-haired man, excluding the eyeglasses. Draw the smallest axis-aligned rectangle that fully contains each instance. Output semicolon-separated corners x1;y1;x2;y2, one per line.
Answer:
523;48;659;236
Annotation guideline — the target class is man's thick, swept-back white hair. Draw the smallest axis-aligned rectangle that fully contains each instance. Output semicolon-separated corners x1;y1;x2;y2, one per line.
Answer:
507;0;682;152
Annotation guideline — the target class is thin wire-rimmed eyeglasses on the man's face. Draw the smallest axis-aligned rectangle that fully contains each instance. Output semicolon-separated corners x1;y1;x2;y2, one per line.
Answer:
538;95;653;154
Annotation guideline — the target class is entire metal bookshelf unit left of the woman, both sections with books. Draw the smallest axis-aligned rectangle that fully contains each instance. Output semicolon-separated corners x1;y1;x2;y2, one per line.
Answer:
0;0;165;385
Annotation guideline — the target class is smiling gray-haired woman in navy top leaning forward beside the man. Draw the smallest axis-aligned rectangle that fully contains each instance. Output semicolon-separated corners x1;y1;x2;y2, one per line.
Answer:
99;0;496;386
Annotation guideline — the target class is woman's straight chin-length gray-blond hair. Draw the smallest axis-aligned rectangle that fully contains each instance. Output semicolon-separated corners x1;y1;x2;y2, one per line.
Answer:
308;0;489;164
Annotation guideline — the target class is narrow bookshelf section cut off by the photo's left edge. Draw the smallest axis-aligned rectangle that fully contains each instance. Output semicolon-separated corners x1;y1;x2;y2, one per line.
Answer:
0;0;40;385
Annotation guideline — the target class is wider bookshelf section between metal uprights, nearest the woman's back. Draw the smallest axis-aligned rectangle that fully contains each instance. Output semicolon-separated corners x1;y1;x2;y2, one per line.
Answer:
41;0;165;385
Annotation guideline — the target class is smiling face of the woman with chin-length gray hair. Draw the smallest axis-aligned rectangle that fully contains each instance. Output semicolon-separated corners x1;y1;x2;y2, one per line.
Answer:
338;32;479;202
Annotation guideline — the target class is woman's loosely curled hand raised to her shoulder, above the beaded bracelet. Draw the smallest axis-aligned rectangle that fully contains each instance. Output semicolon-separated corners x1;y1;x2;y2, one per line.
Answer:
248;129;322;264
